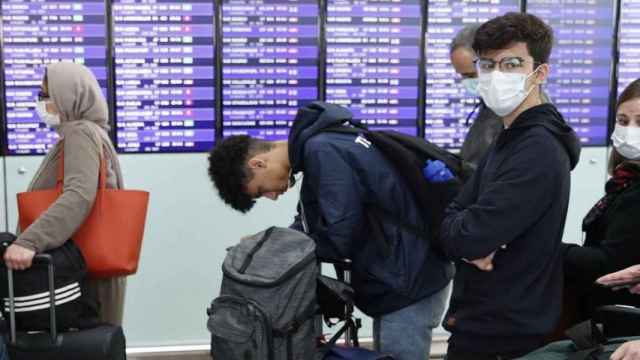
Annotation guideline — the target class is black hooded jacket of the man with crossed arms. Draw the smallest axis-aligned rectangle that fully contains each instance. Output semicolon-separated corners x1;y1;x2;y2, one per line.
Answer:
442;104;580;352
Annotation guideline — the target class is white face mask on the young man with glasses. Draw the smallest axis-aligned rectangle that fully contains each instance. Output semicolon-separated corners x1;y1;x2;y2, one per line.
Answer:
478;69;538;116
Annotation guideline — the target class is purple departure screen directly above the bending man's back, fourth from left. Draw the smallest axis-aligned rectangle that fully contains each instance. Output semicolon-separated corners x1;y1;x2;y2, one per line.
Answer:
325;0;422;135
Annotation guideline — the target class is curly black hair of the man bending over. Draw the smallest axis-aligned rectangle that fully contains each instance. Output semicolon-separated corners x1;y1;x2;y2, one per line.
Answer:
209;135;271;213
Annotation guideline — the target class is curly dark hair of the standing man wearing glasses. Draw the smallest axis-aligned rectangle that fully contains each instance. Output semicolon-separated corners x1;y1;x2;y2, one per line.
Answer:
473;12;553;64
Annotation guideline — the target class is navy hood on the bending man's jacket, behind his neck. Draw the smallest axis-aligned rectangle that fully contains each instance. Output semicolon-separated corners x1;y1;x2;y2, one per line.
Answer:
289;101;360;174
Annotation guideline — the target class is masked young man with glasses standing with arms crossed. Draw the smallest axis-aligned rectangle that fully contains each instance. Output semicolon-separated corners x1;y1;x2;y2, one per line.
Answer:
440;13;580;360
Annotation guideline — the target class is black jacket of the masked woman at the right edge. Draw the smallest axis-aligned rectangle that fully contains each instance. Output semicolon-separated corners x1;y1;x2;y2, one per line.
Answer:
563;163;640;319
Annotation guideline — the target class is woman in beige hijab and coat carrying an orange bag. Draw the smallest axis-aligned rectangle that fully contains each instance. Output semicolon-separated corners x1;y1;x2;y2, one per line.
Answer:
4;62;126;325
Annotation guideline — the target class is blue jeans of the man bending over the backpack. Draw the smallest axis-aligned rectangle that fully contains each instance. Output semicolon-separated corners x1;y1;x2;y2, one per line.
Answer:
373;286;449;360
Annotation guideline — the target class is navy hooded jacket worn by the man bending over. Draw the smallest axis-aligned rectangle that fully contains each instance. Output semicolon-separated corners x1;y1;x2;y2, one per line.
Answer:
289;102;453;316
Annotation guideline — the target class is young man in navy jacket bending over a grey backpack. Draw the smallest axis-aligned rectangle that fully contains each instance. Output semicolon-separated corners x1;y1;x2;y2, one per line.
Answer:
209;103;453;360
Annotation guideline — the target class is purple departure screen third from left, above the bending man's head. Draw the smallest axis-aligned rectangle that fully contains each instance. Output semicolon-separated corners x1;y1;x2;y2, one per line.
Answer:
222;0;319;140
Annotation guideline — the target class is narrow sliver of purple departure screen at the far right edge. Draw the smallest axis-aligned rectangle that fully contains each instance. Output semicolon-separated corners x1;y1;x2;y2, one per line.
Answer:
618;0;640;95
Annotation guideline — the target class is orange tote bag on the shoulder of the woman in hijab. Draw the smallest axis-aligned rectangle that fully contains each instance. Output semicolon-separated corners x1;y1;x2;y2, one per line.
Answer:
18;146;149;278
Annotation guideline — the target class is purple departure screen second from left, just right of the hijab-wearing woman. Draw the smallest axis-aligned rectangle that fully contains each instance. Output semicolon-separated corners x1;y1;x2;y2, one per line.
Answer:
112;0;215;152
